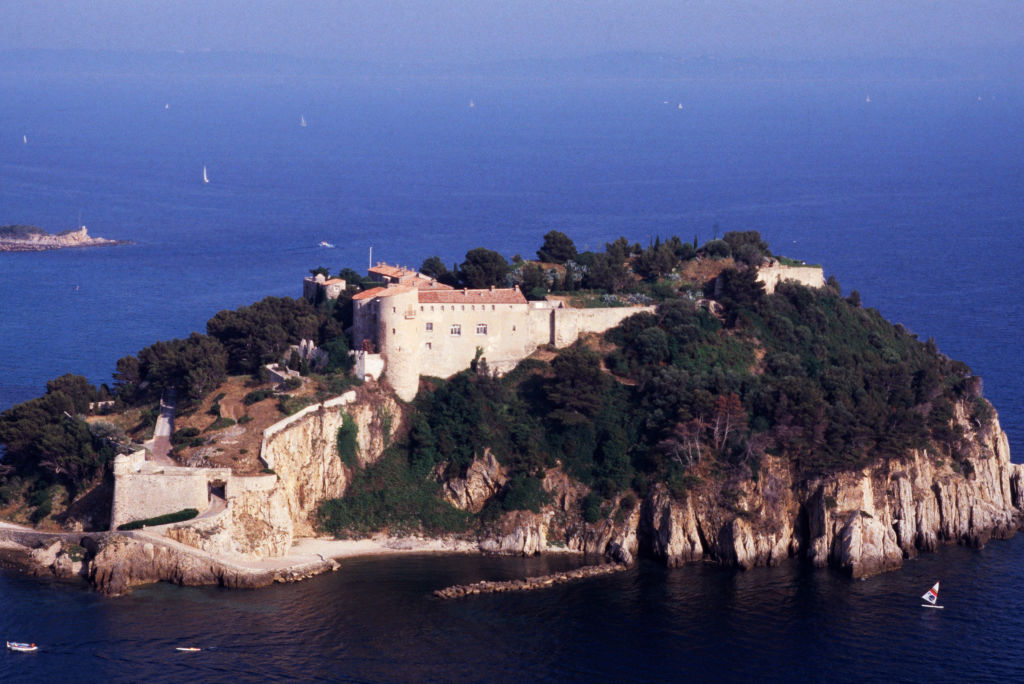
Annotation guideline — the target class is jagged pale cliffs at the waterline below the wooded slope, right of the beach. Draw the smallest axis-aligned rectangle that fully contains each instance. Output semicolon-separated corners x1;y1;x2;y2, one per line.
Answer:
480;403;1024;578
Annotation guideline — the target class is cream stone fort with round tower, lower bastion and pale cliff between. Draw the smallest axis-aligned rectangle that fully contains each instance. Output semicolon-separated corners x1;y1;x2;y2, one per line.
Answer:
101;255;824;559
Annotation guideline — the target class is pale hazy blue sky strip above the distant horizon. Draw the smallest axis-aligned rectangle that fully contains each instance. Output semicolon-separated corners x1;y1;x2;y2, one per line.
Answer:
0;0;1024;66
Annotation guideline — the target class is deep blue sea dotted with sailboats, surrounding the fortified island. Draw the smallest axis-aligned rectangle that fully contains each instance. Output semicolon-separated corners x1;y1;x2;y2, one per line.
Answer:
0;56;1024;682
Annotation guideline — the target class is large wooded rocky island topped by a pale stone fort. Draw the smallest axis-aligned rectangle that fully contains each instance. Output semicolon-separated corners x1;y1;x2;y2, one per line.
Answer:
0;231;1024;596
